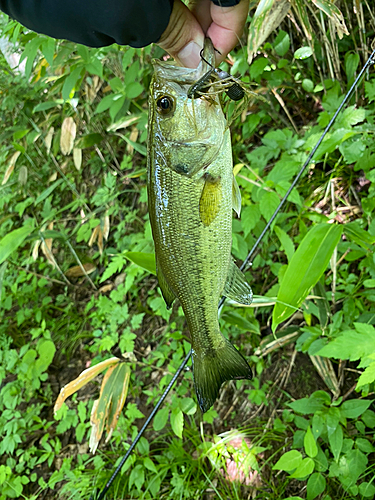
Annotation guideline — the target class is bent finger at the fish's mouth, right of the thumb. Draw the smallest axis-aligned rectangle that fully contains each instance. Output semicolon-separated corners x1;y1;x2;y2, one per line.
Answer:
207;0;249;64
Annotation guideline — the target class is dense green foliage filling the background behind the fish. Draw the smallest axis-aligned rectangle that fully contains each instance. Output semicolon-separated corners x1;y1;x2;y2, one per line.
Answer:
0;0;375;500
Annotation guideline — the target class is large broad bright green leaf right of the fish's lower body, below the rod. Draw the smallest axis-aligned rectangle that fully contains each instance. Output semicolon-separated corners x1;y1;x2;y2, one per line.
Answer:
272;223;342;331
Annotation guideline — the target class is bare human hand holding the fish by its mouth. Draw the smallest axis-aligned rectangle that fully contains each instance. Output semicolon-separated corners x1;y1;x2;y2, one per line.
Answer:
157;0;249;68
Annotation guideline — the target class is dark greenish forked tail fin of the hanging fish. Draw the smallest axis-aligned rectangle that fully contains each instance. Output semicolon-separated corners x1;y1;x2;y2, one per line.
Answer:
192;334;252;413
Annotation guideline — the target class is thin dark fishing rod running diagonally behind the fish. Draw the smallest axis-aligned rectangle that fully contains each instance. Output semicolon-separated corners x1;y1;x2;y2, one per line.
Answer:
89;49;375;500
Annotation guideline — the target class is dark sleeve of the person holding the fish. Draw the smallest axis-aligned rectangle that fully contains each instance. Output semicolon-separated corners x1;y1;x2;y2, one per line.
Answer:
0;0;173;47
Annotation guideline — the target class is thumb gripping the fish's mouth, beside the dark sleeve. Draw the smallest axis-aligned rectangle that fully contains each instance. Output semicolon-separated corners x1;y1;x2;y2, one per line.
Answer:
157;0;204;68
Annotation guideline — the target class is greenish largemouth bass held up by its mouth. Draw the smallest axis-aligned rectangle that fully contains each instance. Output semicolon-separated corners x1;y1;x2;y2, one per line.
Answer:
147;38;252;413
